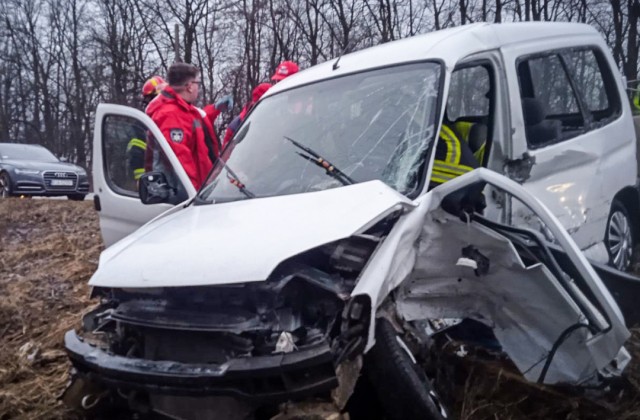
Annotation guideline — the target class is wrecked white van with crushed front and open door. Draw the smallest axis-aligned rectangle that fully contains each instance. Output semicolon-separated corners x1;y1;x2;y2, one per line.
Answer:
65;23;637;419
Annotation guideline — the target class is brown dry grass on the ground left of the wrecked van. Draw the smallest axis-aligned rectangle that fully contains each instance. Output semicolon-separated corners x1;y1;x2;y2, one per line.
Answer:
0;199;102;420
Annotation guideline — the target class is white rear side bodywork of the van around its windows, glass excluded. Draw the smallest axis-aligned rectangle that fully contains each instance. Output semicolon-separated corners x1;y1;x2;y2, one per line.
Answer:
501;30;638;263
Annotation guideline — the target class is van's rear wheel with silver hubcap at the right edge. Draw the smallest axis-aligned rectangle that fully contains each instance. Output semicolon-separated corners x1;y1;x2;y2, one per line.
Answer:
604;200;635;271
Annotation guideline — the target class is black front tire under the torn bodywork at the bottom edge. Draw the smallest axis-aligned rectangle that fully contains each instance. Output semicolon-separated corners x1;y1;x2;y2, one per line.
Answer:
365;319;447;420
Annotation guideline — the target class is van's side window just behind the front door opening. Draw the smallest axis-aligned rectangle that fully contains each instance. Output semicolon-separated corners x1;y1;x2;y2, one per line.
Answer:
518;53;585;148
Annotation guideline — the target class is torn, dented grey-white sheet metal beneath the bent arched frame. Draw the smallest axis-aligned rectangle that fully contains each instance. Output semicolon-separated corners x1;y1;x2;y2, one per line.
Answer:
397;207;608;384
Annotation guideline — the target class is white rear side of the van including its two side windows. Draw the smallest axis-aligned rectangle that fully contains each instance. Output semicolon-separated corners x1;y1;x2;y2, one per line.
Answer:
505;36;637;262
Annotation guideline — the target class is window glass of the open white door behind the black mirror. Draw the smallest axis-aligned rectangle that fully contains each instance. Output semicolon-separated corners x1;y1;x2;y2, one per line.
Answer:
102;115;187;204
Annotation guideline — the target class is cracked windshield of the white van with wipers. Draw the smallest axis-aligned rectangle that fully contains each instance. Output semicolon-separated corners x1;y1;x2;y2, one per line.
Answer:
199;63;441;203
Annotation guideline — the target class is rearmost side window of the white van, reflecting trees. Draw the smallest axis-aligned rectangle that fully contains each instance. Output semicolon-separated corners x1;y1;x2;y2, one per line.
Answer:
563;48;620;126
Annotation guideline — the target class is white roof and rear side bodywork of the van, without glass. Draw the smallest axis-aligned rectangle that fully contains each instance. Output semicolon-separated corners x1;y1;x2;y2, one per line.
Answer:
263;22;638;263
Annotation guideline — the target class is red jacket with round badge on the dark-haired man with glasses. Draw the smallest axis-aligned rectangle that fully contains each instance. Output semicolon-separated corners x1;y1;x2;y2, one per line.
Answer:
147;86;221;189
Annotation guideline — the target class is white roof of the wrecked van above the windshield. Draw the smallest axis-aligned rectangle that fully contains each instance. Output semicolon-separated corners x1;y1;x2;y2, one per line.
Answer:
265;22;600;97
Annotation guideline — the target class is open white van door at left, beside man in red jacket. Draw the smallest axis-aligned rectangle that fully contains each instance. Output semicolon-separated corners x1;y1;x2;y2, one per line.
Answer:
93;104;196;247
